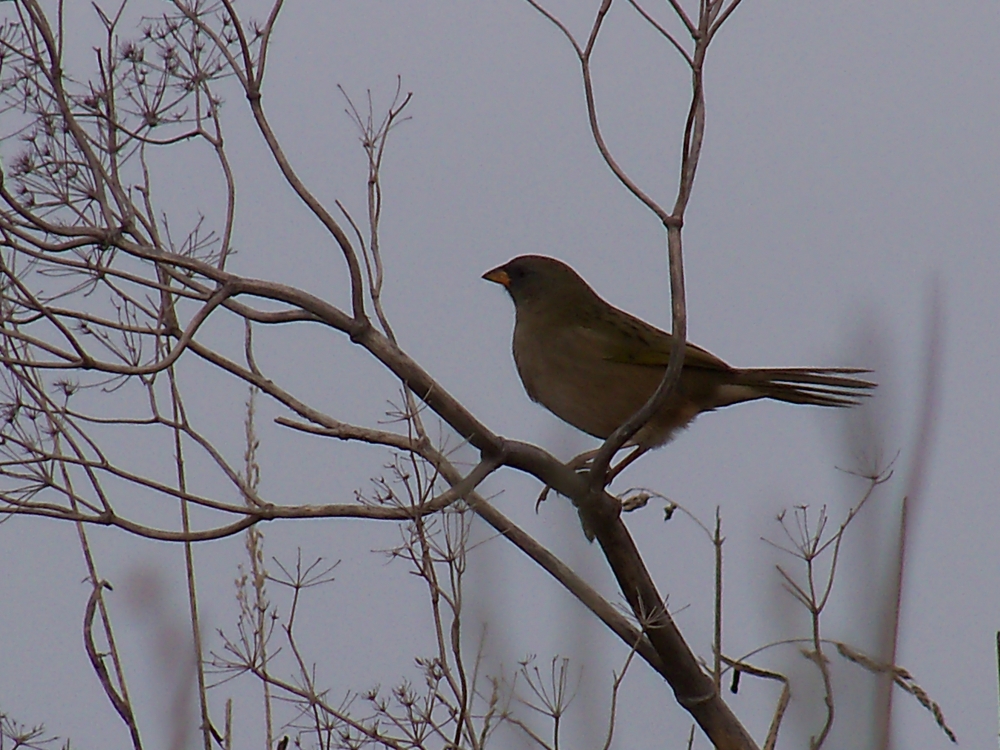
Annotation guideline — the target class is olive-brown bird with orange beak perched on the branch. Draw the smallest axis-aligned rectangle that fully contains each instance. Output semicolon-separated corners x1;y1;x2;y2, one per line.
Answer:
483;255;875;476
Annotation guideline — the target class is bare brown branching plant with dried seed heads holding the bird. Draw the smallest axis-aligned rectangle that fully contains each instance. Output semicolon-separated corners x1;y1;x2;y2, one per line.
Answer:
0;0;943;749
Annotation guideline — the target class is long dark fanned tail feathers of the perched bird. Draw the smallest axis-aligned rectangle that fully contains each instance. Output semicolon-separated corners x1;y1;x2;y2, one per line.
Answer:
732;367;876;406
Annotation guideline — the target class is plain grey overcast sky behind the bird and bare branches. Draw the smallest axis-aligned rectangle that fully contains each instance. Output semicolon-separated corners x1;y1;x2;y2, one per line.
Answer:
0;0;1000;748
